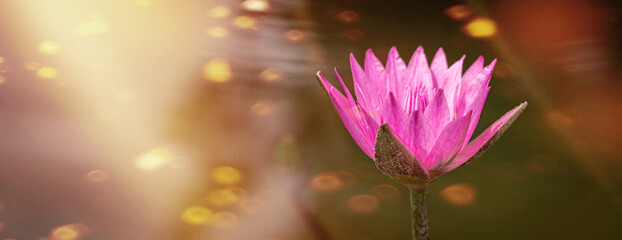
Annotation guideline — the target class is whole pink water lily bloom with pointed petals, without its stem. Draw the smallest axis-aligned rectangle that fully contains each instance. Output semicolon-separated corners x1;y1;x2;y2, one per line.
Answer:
317;47;527;184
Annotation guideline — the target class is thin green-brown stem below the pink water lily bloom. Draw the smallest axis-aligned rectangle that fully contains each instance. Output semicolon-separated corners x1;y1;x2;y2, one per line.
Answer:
409;185;430;240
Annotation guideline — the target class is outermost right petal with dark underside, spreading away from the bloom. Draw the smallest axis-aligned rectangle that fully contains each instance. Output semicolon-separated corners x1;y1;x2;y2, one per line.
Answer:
443;102;527;173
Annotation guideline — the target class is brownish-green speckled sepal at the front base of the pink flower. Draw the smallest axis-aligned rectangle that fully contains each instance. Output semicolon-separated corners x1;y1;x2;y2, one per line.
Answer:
374;124;430;182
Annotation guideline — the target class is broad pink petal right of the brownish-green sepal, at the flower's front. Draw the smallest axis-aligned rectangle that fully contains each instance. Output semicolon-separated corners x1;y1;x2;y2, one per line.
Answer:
424;113;471;170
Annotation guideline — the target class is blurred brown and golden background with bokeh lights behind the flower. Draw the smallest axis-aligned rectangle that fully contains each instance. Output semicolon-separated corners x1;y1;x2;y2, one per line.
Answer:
0;0;622;240
